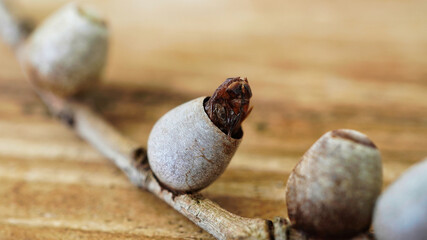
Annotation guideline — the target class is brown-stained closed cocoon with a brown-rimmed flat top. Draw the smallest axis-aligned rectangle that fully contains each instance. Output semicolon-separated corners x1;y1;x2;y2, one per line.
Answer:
286;129;382;237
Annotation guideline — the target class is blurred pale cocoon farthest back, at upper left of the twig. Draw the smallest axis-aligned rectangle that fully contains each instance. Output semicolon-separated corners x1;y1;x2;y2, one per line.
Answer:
20;3;108;96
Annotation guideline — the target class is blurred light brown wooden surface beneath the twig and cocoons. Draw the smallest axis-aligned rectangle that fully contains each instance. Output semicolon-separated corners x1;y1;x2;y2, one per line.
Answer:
0;0;427;239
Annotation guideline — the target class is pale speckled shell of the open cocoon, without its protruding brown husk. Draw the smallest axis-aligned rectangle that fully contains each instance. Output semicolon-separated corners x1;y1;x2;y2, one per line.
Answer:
147;97;241;192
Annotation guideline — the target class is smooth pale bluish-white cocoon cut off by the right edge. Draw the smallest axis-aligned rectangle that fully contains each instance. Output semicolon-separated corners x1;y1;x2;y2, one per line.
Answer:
374;158;427;240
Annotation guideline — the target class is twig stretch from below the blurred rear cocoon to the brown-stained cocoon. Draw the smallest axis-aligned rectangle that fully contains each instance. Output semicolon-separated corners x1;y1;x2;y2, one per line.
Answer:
38;90;280;239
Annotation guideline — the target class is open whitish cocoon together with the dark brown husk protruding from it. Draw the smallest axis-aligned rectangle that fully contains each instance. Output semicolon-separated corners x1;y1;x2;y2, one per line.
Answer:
147;78;252;193
